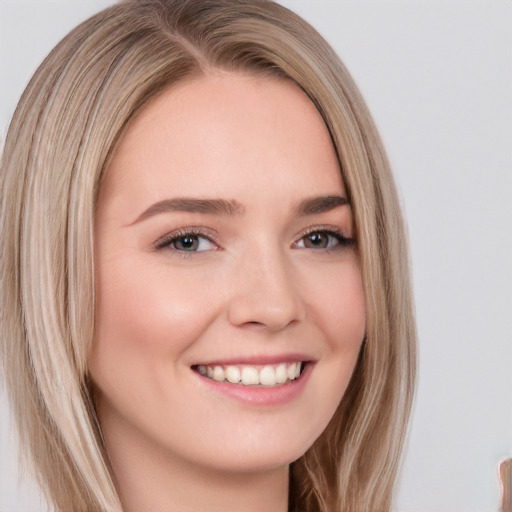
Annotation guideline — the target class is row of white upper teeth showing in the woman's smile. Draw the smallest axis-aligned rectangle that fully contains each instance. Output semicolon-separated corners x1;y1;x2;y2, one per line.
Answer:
197;362;302;386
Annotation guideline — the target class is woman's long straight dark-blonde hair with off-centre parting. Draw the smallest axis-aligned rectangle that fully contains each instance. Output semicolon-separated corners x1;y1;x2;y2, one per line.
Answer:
0;0;416;512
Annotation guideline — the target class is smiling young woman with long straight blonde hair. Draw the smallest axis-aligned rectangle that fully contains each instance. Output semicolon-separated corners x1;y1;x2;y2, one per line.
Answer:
2;0;415;511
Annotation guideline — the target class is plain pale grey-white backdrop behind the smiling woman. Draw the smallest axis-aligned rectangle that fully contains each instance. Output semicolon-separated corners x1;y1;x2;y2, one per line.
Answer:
0;0;512;512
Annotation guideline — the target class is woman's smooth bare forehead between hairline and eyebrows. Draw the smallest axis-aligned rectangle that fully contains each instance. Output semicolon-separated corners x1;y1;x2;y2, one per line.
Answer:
102;72;343;210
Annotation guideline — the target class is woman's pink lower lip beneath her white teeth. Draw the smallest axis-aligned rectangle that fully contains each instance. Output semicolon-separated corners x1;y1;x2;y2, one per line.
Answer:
196;363;313;406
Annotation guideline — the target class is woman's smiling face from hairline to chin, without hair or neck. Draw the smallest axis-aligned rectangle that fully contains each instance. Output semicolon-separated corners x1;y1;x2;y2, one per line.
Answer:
90;72;365;471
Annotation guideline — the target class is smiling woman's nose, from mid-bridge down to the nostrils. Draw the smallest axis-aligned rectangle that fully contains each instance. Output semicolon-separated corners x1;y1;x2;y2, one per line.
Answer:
228;245;305;331
